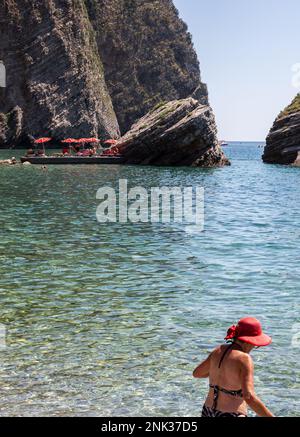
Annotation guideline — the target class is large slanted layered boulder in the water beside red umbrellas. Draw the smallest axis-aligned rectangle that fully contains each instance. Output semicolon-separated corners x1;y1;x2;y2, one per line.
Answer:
118;98;230;167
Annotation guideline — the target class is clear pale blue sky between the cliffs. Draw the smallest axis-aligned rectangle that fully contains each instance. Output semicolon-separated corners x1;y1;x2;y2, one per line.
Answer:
174;0;300;141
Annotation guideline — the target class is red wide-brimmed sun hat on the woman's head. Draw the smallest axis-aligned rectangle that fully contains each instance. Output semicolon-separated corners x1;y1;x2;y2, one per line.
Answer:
225;317;272;347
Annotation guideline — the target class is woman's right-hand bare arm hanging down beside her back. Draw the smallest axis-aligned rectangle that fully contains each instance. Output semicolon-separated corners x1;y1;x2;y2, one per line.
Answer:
241;356;274;417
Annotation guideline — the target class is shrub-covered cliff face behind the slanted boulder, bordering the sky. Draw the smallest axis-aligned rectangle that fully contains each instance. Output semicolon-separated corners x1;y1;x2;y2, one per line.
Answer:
86;0;208;133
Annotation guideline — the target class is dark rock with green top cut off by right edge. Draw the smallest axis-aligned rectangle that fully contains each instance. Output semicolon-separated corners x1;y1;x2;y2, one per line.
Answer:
263;94;300;165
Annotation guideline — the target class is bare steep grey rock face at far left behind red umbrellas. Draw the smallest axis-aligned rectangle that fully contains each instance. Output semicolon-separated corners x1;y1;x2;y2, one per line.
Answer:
0;0;119;146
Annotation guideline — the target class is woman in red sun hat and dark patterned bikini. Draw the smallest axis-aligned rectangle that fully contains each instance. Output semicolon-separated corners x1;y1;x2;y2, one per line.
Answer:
194;317;274;417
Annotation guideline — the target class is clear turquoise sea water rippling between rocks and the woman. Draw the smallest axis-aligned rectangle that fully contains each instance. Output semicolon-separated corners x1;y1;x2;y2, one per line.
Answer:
0;144;300;416
